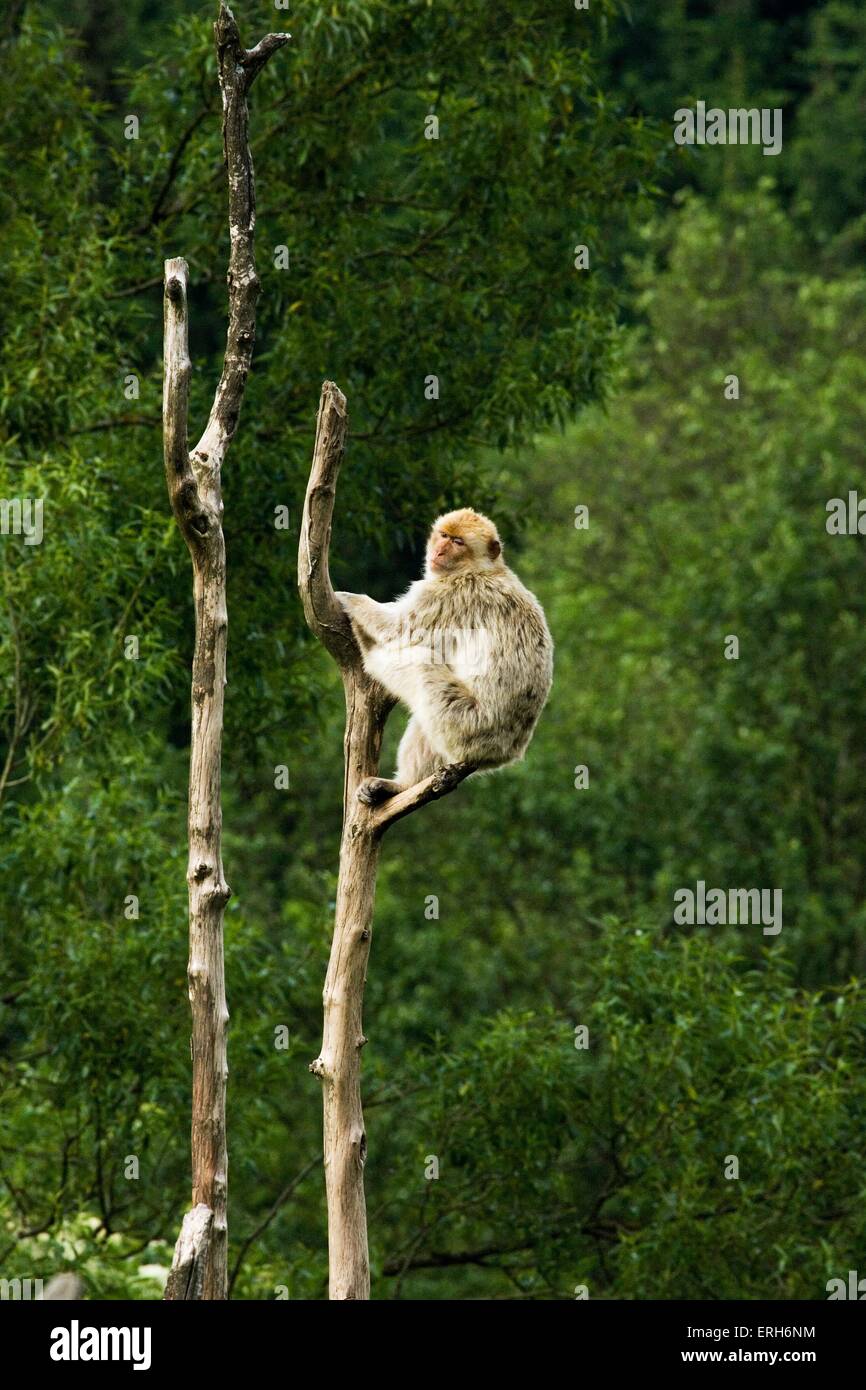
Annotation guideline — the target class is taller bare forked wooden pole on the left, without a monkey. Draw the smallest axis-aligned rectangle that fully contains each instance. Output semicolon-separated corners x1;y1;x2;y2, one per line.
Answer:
163;4;289;1300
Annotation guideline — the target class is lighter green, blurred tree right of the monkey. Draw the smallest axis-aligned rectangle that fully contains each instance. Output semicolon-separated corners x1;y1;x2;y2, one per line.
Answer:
508;188;866;981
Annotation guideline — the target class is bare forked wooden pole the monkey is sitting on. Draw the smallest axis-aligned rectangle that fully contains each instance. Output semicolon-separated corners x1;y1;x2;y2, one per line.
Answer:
297;381;473;1300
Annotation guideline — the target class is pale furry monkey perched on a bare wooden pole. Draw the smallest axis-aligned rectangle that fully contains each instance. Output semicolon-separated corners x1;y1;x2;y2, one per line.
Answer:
336;507;553;806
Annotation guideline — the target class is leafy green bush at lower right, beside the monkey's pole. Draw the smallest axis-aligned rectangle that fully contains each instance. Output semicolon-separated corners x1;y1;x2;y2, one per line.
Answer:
358;923;866;1298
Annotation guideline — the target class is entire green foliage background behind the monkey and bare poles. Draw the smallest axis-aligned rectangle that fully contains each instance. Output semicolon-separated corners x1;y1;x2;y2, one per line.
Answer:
0;0;866;1300
